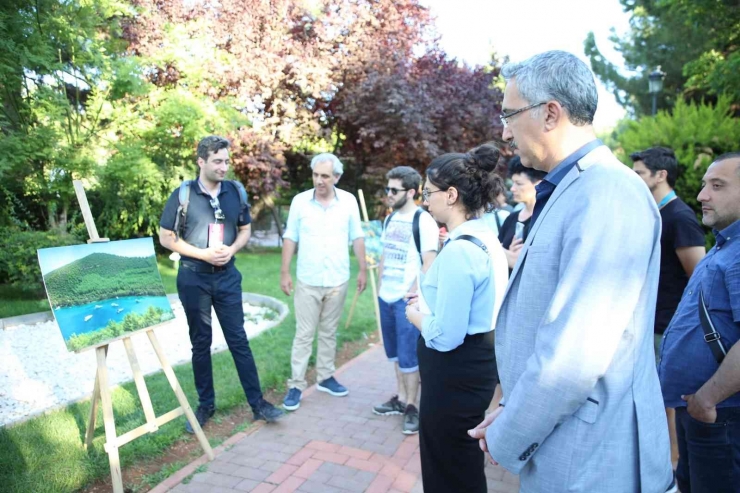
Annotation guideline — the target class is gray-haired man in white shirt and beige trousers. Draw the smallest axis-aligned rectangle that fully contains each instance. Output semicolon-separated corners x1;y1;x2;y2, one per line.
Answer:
280;153;367;411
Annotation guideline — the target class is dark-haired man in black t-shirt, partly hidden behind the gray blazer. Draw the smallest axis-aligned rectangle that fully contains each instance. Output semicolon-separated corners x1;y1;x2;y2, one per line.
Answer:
630;147;706;463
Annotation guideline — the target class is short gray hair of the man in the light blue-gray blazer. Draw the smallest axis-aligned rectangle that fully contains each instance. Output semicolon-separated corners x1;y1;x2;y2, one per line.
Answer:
501;51;599;126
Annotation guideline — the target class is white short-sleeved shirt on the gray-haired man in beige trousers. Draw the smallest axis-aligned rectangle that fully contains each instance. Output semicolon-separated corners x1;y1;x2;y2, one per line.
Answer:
283;188;365;287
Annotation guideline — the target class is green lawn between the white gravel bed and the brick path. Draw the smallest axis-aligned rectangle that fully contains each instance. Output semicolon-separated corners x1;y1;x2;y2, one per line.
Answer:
0;250;375;493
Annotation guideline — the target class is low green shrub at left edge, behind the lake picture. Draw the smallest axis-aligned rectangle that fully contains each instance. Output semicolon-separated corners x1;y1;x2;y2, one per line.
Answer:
0;228;82;293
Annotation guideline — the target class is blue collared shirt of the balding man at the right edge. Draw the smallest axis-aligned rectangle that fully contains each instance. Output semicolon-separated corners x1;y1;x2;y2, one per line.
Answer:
658;221;740;407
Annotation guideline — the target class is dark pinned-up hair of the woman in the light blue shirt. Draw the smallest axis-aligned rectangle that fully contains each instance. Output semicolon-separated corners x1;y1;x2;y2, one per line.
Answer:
426;144;504;217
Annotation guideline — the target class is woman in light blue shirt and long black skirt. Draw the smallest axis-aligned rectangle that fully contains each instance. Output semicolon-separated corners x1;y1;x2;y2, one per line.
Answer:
406;144;509;493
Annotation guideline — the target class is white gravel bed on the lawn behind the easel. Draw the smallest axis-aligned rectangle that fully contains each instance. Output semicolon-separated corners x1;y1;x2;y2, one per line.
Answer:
0;302;276;426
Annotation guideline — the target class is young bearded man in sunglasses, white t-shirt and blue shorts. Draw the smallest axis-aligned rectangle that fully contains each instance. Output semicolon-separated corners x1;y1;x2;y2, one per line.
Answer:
373;166;439;435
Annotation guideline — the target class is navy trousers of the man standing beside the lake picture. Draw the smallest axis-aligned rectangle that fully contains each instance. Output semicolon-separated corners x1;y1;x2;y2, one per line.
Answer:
177;264;262;409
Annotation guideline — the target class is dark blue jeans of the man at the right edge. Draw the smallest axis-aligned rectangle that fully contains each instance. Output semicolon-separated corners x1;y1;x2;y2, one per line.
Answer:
676;407;740;493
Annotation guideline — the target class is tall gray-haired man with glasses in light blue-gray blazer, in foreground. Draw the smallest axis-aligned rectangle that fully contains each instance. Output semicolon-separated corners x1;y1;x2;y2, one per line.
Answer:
470;51;675;493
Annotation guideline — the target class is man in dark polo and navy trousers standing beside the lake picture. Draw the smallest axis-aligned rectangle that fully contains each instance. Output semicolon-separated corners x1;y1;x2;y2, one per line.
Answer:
159;136;283;433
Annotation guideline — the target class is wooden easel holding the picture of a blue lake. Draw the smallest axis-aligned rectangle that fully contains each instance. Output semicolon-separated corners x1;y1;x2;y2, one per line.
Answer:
74;180;215;493
